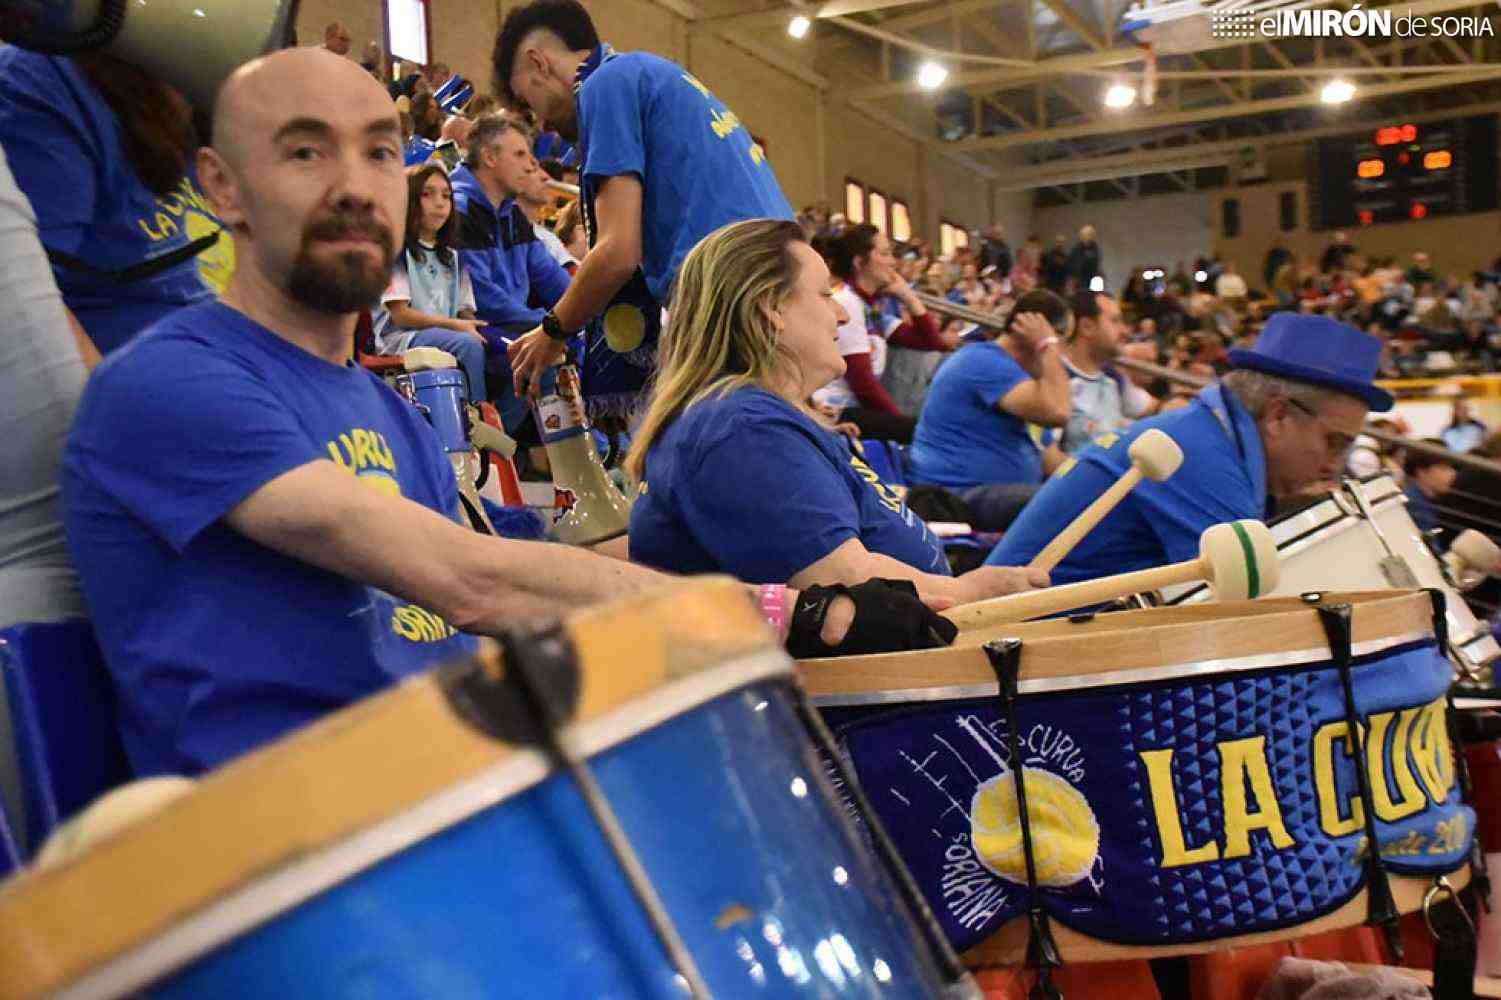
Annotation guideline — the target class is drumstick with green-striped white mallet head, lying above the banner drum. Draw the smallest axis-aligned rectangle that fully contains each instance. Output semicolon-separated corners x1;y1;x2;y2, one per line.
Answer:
943;521;1282;632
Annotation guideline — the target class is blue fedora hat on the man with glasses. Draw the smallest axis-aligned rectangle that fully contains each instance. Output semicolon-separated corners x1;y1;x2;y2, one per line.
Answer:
1229;312;1393;413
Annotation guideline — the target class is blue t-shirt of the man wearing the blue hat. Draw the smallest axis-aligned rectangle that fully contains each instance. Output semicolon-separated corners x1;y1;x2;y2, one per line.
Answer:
986;384;1267;584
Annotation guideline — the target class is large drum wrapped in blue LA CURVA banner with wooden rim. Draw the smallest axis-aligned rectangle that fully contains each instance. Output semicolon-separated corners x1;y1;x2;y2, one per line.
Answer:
802;590;1474;964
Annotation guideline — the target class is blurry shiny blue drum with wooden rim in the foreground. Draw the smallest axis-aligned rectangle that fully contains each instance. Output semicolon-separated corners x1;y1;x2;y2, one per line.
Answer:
0;583;952;1000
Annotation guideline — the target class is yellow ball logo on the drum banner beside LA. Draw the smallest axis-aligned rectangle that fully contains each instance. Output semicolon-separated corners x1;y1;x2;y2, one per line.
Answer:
970;767;1100;887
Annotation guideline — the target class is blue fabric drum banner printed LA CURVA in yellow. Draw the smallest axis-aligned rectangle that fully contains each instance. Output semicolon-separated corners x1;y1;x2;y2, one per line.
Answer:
826;641;1474;949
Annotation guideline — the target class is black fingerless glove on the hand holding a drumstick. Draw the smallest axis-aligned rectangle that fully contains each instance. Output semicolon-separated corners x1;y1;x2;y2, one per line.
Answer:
787;580;959;659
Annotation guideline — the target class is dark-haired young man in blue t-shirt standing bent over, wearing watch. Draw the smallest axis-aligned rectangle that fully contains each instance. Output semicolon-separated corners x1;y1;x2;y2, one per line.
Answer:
494;0;793;411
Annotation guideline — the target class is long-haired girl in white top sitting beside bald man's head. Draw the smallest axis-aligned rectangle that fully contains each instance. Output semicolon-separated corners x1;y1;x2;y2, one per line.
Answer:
375;164;485;401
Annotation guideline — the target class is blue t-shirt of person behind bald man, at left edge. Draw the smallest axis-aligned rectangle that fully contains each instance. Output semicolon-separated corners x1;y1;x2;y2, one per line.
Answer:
0;45;234;353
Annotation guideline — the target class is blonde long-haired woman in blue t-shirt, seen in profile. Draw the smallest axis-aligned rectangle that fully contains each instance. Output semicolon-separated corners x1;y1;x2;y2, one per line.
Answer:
626;219;1046;607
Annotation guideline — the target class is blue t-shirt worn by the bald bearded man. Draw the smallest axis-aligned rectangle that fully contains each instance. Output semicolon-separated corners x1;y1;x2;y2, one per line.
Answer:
63;302;473;775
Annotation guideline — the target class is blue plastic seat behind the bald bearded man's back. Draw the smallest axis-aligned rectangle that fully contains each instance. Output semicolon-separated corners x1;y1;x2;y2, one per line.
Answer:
0;622;131;850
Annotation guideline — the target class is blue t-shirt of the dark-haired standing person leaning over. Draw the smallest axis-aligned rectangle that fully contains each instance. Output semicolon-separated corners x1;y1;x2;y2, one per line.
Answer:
578;48;793;303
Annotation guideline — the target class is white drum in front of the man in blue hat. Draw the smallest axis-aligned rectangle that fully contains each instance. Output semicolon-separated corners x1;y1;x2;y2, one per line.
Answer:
1163;476;1501;670
